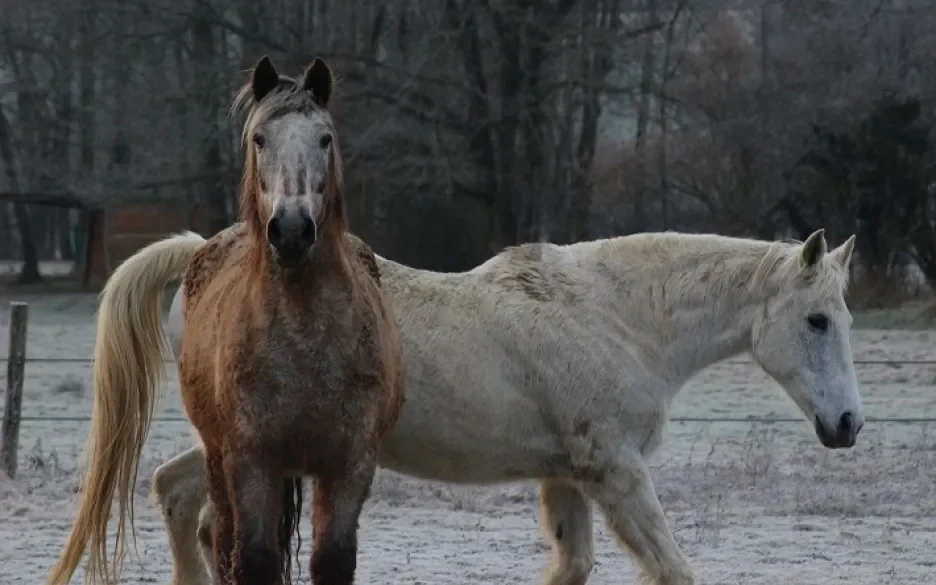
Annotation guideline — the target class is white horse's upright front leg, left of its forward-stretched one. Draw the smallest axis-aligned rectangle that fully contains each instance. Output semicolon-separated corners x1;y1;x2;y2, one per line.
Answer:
540;480;595;585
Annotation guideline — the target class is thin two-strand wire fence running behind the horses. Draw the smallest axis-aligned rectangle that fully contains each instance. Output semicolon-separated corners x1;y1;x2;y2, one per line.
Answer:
0;357;936;424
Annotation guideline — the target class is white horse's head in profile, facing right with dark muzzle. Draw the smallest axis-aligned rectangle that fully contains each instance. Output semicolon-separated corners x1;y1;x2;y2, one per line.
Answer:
751;230;864;449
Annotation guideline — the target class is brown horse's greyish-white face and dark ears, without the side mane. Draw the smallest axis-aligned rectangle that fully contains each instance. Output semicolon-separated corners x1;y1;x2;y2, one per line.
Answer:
249;60;335;268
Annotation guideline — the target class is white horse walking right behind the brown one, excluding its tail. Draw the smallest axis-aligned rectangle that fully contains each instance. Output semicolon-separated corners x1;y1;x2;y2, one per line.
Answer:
141;226;864;585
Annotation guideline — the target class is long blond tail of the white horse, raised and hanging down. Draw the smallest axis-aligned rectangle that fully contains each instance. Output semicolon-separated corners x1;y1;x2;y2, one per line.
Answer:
47;232;205;585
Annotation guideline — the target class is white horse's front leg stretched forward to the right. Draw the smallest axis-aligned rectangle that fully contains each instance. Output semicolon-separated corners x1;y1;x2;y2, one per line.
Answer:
582;450;695;585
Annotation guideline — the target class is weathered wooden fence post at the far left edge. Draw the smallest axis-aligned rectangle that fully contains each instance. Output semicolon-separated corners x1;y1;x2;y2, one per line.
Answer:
0;303;29;479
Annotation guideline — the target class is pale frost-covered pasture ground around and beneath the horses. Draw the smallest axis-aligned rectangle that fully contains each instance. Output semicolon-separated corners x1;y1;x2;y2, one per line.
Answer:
0;291;936;585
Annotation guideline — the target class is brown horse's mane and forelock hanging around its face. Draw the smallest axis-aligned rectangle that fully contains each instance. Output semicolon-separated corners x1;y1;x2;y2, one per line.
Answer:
231;75;348;245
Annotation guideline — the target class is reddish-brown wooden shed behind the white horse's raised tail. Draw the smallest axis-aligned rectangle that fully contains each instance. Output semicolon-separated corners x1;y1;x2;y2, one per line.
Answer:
88;204;212;286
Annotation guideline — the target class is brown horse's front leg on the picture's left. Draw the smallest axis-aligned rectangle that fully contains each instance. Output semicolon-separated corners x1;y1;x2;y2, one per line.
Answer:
225;449;285;585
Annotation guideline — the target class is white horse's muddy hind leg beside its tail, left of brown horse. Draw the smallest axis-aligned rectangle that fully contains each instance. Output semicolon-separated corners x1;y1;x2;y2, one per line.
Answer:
153;447;210;585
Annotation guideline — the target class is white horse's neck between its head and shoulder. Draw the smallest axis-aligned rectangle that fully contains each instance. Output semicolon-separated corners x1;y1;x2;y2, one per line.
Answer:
579;234;784;400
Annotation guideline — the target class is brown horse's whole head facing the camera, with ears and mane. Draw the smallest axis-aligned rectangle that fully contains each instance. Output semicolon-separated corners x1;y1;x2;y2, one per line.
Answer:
236;57;344;268
